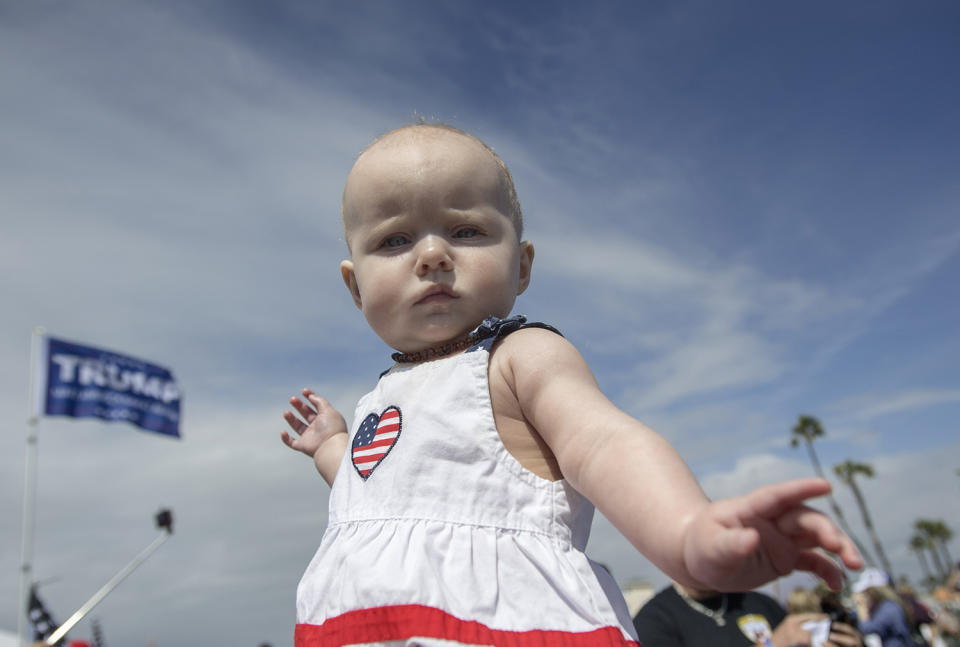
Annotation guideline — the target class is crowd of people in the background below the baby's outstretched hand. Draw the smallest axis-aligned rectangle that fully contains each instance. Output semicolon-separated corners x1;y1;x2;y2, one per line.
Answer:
634;564;960;647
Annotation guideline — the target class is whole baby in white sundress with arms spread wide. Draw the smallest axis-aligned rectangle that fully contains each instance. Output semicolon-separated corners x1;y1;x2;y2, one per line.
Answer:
282;124;861;646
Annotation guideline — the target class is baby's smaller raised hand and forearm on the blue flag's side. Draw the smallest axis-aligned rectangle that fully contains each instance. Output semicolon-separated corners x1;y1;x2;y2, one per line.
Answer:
280;389;347;485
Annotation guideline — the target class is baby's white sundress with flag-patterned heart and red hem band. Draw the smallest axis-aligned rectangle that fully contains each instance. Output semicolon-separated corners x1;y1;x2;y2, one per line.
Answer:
295;316;636;647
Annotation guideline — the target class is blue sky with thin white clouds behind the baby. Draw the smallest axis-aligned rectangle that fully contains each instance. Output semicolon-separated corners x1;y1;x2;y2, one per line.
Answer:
0;1;960;645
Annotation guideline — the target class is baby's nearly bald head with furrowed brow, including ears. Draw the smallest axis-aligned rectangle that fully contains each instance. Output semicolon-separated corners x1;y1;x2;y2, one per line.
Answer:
340;128;533;353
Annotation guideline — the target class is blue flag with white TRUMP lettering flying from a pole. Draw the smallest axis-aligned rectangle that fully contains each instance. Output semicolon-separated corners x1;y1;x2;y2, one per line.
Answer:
37;337;180;438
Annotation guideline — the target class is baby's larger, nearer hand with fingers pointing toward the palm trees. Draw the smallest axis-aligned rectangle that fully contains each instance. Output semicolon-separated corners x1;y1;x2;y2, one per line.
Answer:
684;478;863;591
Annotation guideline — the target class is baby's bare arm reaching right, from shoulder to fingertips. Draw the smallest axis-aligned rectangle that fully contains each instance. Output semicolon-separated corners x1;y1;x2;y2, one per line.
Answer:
506;329;861;591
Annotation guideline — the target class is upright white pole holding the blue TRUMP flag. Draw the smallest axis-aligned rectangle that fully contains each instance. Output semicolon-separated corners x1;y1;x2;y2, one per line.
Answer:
17;327;46;647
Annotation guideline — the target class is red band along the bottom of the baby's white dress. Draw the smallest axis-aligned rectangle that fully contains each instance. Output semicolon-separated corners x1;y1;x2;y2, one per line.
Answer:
293;604;639;647
